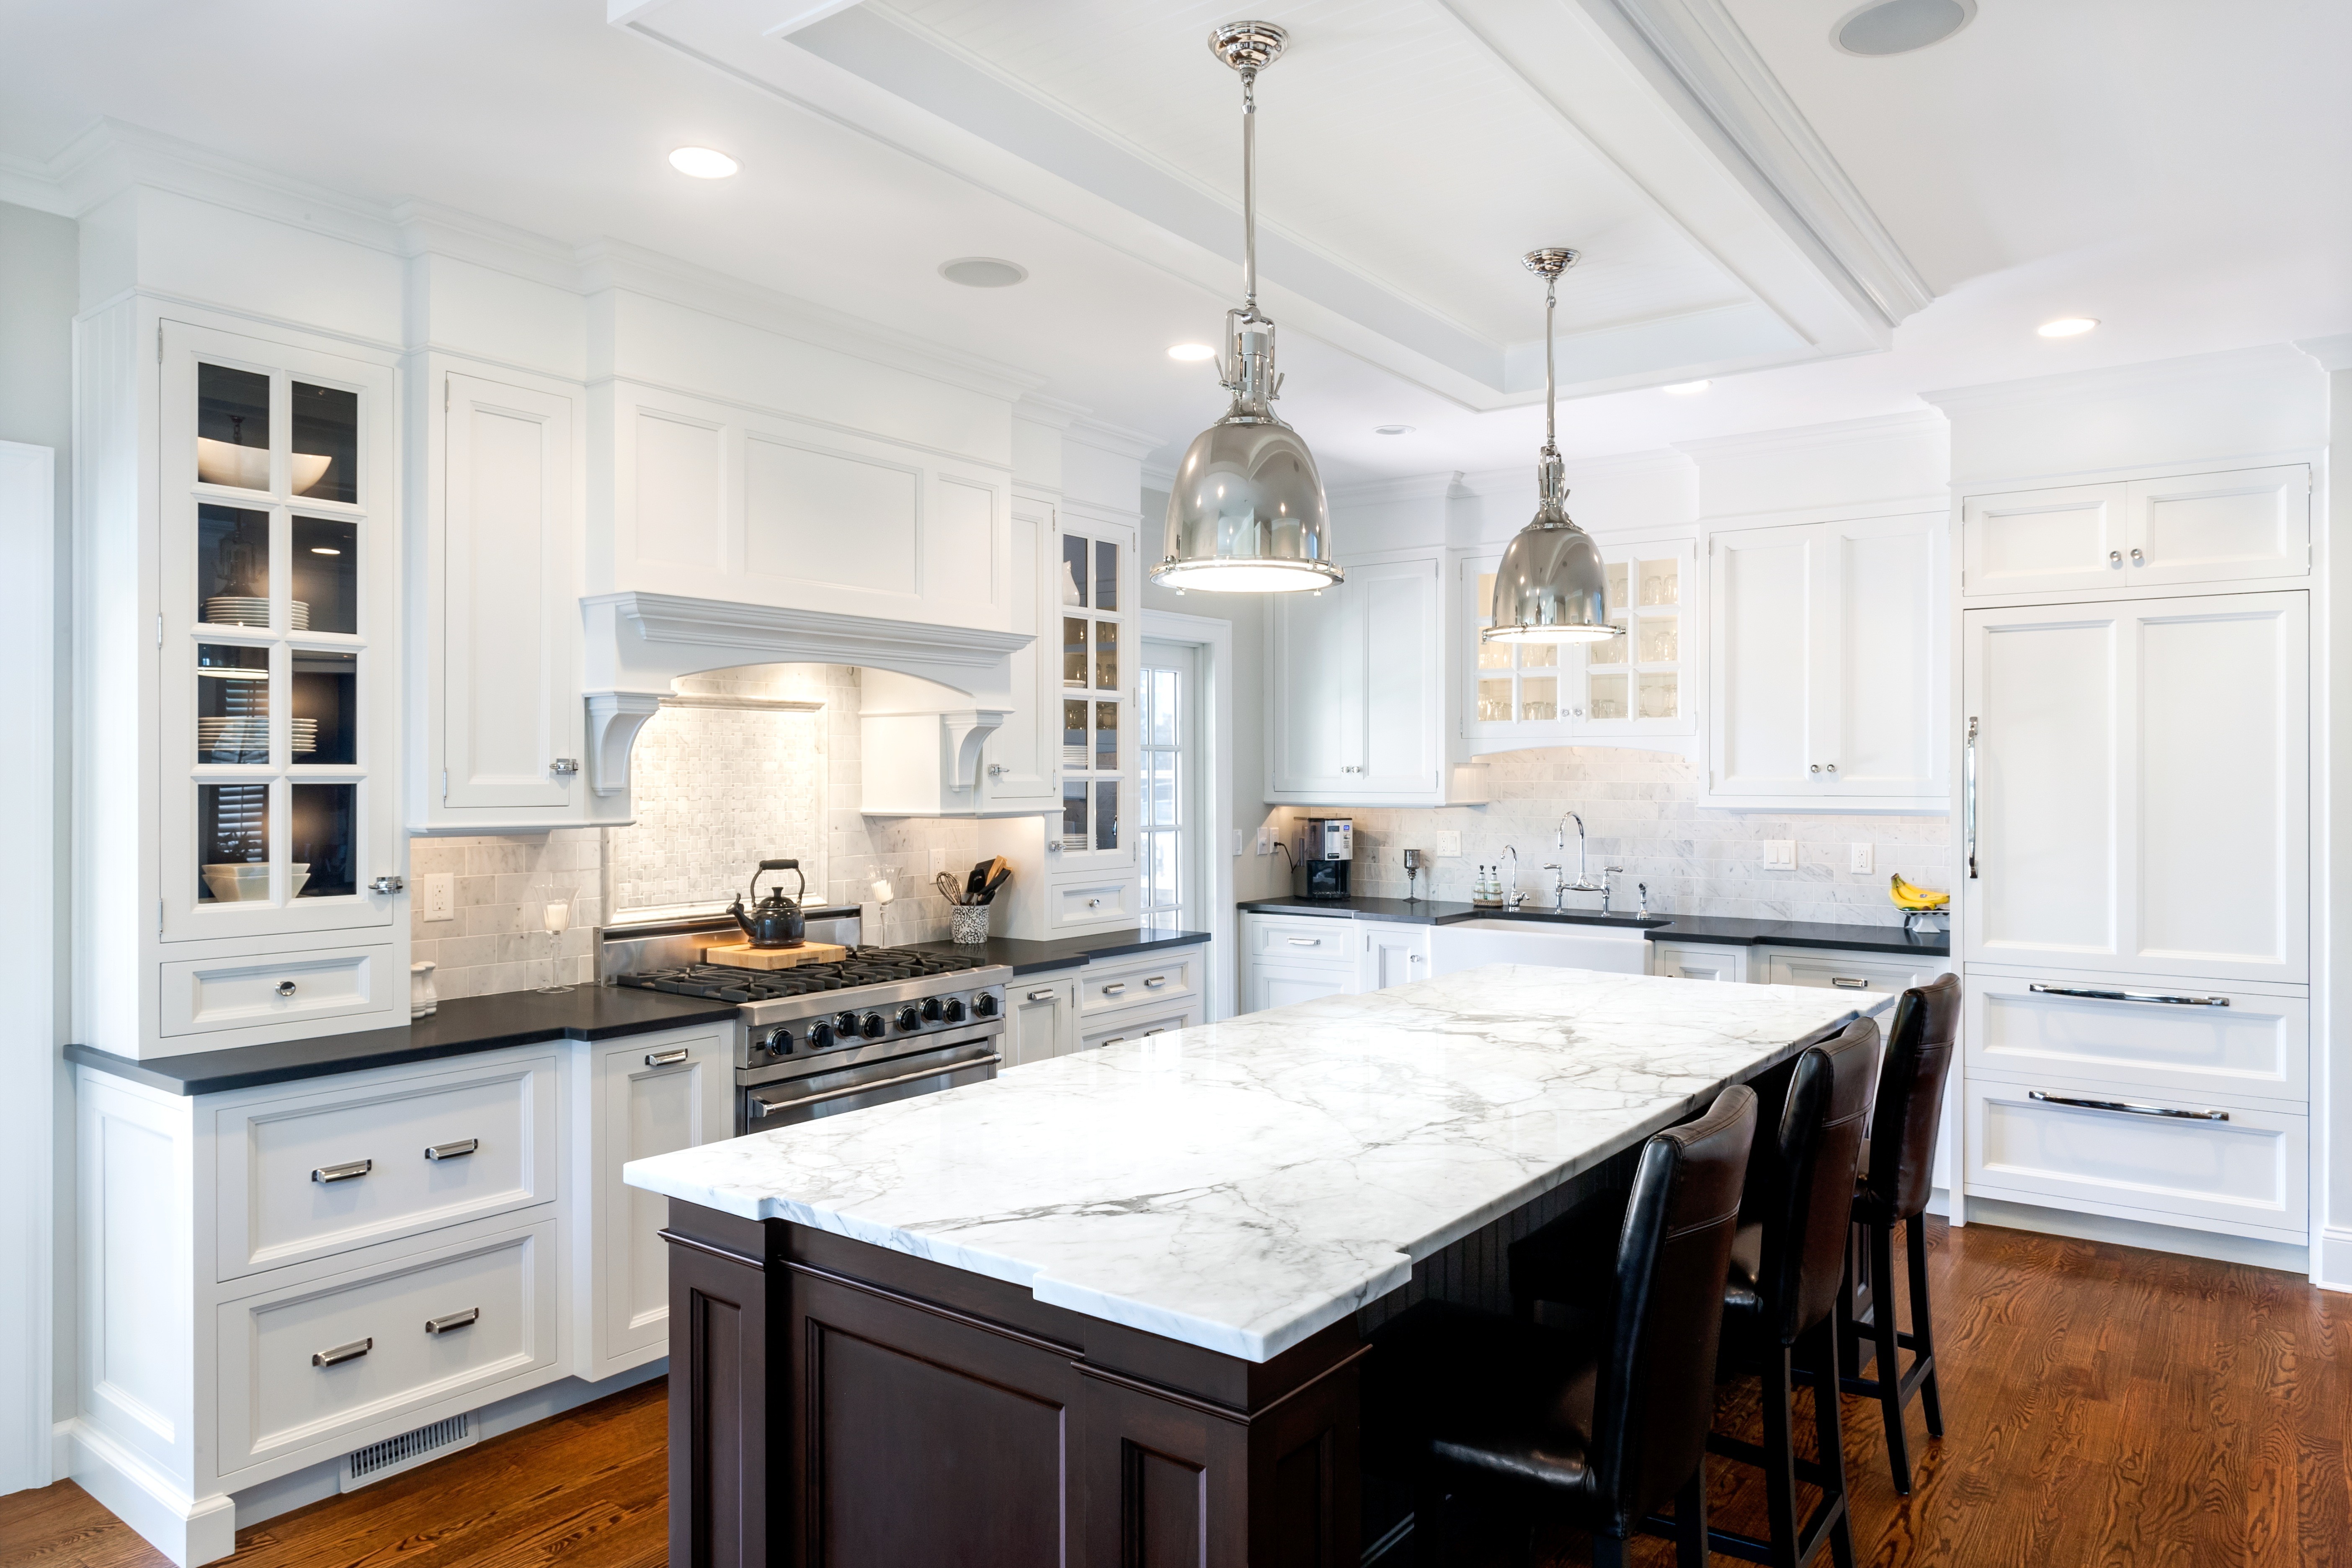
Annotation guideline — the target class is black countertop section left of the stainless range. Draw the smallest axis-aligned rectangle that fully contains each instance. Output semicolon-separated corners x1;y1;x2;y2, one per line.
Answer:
66;985;736;1096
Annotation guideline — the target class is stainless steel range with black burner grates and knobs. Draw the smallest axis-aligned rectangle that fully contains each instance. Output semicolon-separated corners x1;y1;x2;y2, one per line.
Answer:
597;910;1014;1133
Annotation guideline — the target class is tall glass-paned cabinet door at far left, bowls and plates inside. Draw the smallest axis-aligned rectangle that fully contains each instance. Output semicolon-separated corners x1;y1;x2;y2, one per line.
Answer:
157;322;400;940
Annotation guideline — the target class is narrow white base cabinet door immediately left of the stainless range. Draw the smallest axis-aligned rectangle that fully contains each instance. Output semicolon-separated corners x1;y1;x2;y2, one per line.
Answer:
572;1023;736;1382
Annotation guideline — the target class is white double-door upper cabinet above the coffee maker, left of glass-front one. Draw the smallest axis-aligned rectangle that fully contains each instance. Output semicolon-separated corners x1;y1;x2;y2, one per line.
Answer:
1265;557;1454;806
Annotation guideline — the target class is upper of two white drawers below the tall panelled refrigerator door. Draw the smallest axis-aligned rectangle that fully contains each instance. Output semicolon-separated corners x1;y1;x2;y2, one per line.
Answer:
1962;973;2310;1112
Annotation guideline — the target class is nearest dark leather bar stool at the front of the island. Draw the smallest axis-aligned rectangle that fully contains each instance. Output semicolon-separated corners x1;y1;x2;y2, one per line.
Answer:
1364;1084;1757;1568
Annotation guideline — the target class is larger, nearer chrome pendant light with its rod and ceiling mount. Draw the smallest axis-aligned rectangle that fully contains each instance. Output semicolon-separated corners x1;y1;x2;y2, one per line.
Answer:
1153;21;1343;593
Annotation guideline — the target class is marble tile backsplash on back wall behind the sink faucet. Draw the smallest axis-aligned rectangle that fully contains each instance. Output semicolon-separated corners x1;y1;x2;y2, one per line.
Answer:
1291;745;1952;926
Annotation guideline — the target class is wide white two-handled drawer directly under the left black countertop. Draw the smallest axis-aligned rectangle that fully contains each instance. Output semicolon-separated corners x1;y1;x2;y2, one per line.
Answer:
211;1048;555;1279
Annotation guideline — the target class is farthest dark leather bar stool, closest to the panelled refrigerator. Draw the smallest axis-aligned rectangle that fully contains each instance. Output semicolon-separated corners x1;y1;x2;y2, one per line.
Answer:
1837;975;1959;1498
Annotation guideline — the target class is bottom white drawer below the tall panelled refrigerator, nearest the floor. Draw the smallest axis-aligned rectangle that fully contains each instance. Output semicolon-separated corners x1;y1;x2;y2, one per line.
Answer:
1966;1072;2310;1241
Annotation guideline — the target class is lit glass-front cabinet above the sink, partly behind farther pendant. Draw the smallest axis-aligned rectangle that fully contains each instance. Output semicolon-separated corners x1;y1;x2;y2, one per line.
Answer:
1461;538;1698;750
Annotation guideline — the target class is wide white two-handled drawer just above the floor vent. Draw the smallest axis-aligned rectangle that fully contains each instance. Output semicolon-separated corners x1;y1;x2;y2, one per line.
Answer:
217;1220;555;1476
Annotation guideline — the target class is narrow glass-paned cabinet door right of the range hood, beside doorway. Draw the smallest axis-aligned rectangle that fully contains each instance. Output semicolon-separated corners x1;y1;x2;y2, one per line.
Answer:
1068;513;1138;865
